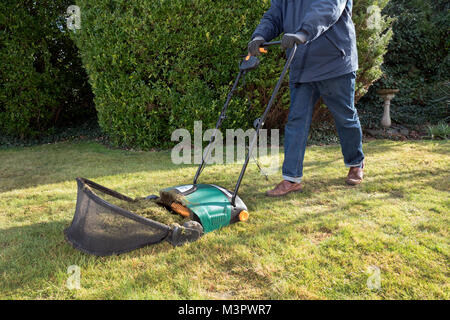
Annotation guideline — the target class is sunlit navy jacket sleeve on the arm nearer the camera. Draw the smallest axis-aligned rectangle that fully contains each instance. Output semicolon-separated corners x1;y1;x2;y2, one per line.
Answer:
297;0;348;41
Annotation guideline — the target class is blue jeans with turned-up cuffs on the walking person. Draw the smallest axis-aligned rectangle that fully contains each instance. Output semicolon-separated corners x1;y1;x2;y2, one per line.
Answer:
283;72;364;183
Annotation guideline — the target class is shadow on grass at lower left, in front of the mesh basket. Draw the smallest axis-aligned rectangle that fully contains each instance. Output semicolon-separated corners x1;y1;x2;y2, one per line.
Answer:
0;221;172;295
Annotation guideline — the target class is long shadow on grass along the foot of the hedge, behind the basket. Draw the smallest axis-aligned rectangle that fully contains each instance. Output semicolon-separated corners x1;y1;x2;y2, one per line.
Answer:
0;142;197;193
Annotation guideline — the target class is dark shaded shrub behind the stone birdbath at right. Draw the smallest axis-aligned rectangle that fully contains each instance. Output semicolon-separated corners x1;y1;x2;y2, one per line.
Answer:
359;0;450;127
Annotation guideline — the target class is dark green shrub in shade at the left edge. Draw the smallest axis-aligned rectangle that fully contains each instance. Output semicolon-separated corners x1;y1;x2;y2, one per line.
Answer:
0;0;95;138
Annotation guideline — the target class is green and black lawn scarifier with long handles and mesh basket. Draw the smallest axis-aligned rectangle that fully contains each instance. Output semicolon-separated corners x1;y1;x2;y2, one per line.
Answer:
64;41;297;256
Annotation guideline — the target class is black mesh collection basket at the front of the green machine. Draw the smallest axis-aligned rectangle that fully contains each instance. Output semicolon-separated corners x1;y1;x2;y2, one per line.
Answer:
64;178;174;256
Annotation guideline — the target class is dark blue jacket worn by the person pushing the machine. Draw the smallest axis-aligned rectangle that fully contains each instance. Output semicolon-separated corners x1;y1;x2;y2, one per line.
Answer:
252;0;358;83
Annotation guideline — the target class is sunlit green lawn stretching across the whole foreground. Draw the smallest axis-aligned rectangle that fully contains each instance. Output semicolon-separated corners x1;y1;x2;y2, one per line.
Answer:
0;141;450;299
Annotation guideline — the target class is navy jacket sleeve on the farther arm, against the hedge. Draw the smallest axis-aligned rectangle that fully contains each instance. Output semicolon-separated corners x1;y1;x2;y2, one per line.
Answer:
252;0;283;41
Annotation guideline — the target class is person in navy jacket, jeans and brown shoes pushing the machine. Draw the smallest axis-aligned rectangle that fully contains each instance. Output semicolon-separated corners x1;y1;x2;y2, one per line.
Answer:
248;0;364;197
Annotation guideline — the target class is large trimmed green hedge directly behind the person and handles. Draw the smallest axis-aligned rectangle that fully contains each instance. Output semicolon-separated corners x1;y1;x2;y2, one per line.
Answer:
73;0;389;149
